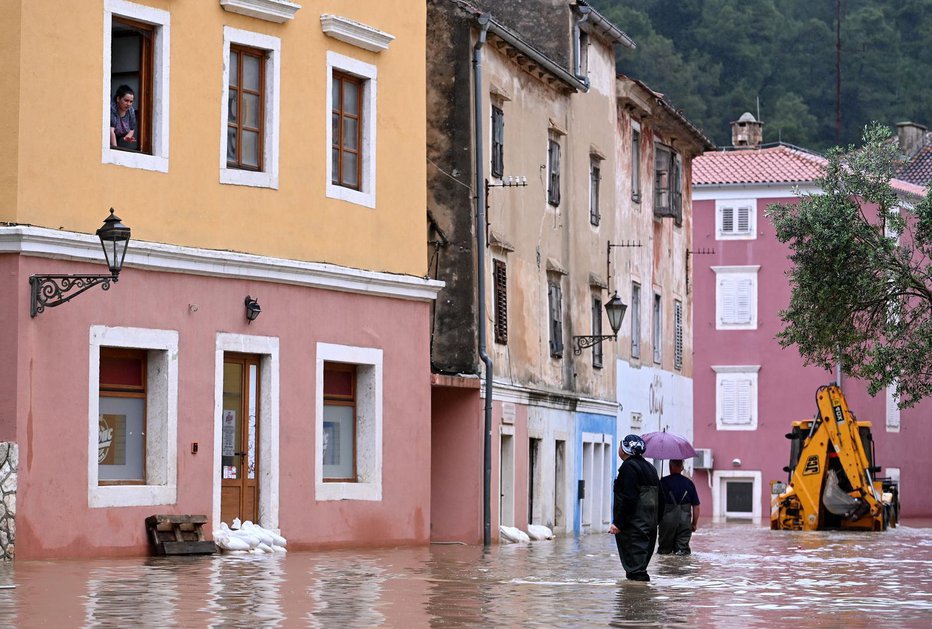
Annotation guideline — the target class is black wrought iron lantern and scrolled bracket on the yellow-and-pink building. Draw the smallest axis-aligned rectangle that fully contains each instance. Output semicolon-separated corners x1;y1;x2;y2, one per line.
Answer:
29;208;131;317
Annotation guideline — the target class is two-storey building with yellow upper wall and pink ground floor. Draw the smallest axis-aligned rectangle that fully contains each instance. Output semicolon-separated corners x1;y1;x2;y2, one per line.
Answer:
0;0;440;557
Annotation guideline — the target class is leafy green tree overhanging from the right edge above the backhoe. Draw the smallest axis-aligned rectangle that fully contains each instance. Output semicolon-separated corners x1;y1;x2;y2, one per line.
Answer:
767;124;932;408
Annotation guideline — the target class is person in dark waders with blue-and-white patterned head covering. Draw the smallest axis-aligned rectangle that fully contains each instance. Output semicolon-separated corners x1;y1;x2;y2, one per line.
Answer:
608;435;663;581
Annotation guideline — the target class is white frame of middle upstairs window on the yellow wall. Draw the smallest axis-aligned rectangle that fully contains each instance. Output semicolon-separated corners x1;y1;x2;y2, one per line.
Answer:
220;26;281;190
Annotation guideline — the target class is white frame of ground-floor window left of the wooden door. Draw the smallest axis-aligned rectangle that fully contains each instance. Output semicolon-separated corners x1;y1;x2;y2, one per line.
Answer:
87;325;178;508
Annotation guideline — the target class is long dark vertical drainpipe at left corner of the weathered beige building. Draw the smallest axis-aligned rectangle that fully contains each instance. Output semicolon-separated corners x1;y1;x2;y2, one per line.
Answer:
472;13;492;546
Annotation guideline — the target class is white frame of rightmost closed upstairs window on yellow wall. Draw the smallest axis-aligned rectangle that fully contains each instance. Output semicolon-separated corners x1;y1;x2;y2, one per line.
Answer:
324;50;379;208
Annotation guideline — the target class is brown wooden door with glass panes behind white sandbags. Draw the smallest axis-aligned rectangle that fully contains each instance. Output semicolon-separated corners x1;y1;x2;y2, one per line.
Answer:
220;353;259;524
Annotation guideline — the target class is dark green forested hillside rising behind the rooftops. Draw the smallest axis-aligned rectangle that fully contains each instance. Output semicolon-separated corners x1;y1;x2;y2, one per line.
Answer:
591;0;932;150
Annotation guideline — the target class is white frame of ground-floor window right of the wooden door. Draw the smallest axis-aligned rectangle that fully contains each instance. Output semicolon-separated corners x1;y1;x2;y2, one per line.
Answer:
314;343;382;501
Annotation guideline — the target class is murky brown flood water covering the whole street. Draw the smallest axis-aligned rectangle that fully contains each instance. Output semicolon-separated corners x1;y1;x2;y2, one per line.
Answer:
0;521;932;627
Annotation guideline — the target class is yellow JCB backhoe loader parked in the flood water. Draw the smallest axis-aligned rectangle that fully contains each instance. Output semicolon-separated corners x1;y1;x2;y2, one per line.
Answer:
770;385;900;531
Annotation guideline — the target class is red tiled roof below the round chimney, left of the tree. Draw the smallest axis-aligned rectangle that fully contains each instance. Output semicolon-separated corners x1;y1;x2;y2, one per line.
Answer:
692;144;828;186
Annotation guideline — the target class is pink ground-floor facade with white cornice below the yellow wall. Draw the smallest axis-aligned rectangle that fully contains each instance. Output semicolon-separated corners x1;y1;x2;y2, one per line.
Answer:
0;233;433;559
